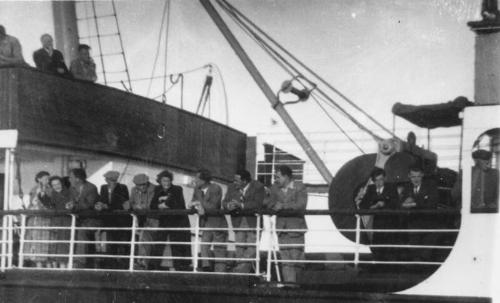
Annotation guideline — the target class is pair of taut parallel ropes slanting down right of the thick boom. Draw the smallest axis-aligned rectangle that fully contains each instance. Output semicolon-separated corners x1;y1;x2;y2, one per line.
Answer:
217;0;397;139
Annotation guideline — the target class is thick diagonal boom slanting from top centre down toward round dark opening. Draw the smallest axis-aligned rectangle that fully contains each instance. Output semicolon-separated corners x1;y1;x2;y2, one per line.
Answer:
200;0;333;184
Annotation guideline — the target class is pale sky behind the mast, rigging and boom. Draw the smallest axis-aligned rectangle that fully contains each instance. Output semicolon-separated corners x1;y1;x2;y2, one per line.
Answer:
0;0;481;180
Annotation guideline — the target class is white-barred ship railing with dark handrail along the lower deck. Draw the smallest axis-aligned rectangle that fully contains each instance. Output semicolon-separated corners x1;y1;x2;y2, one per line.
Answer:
0;209;460;281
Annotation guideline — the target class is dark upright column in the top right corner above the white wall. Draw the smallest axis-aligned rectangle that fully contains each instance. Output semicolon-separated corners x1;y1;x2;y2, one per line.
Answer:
468;0;500;105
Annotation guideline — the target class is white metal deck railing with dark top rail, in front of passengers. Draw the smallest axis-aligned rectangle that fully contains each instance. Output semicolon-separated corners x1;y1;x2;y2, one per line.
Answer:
0;210;460;281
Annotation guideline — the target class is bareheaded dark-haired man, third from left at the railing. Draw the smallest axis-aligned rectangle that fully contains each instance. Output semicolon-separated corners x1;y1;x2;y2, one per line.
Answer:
68;168;99;268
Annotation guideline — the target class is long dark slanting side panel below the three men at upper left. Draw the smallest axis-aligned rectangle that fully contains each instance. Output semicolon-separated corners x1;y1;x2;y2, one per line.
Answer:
0;67;246;180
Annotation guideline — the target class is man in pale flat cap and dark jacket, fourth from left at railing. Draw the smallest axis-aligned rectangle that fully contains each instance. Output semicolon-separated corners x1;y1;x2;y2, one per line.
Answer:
97;170;132;268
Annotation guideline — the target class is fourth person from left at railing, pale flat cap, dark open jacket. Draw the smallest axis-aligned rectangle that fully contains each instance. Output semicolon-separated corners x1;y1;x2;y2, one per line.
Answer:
96;170;132;269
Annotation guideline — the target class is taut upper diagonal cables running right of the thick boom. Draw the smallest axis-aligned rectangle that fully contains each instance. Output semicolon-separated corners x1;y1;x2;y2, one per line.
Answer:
217;0;398;138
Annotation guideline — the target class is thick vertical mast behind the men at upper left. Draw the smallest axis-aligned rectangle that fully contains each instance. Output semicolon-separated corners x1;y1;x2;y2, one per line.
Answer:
52;1;78;66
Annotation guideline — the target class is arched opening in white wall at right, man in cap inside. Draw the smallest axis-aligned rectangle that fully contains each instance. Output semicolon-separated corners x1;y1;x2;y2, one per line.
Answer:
471;128;500;213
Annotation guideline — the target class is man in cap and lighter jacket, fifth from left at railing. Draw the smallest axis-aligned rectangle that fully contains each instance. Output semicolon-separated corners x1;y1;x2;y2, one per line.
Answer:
124;174;159;269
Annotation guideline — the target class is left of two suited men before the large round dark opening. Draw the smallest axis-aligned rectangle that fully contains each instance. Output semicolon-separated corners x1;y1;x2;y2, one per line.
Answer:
359;167;398;260
